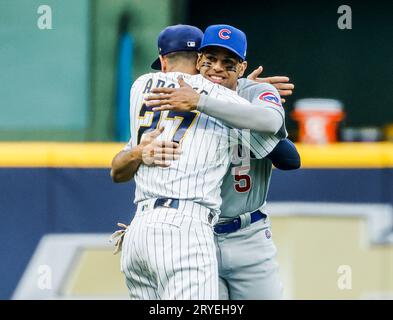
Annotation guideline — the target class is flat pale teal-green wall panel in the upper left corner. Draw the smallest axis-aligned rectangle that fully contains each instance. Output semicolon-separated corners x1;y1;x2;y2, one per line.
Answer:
0;0;89;140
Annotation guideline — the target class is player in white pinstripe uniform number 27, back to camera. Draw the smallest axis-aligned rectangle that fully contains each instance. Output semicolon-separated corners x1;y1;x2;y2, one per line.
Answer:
111;26;282;299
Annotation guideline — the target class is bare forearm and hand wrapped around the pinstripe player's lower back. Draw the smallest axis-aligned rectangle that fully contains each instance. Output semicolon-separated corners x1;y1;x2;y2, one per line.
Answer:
111;127;181;183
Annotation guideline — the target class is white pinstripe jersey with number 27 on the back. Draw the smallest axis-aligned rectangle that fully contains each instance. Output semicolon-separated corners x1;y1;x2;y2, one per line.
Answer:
125;72;278;210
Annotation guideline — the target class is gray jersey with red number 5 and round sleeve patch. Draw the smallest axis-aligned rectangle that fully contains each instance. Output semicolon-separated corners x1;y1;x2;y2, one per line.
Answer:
220;79;288;220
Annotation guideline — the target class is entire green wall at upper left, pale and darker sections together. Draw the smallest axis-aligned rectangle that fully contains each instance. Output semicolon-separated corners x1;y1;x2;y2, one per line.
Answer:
0;0;181;141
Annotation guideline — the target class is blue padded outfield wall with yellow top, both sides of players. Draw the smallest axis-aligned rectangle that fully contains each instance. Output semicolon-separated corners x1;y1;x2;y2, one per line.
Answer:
0;144;393;299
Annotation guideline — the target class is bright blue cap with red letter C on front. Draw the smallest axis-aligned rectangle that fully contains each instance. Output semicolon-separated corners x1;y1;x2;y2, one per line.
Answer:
199;24;247;60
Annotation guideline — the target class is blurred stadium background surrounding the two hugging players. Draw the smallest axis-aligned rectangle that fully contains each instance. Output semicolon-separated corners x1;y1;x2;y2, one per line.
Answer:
0;0;393;299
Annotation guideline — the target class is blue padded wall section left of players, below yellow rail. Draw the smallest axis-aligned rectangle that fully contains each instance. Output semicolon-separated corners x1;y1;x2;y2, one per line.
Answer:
0;168;134;299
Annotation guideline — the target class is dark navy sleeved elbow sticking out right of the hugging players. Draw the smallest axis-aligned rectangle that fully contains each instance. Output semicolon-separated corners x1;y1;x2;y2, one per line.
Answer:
266;139;301;170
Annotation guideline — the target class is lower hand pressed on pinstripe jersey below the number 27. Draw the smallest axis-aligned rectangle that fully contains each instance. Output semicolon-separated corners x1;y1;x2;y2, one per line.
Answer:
140;127;181;168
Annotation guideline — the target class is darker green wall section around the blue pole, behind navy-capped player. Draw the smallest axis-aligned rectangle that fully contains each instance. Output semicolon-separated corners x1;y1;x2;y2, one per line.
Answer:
89;0;172;141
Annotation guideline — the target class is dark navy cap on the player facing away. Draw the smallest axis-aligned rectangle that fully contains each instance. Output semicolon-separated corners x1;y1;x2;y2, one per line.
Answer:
151;24;203;70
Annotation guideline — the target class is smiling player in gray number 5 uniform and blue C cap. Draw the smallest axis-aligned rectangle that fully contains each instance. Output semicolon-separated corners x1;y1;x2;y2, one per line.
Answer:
144;25;300;300
